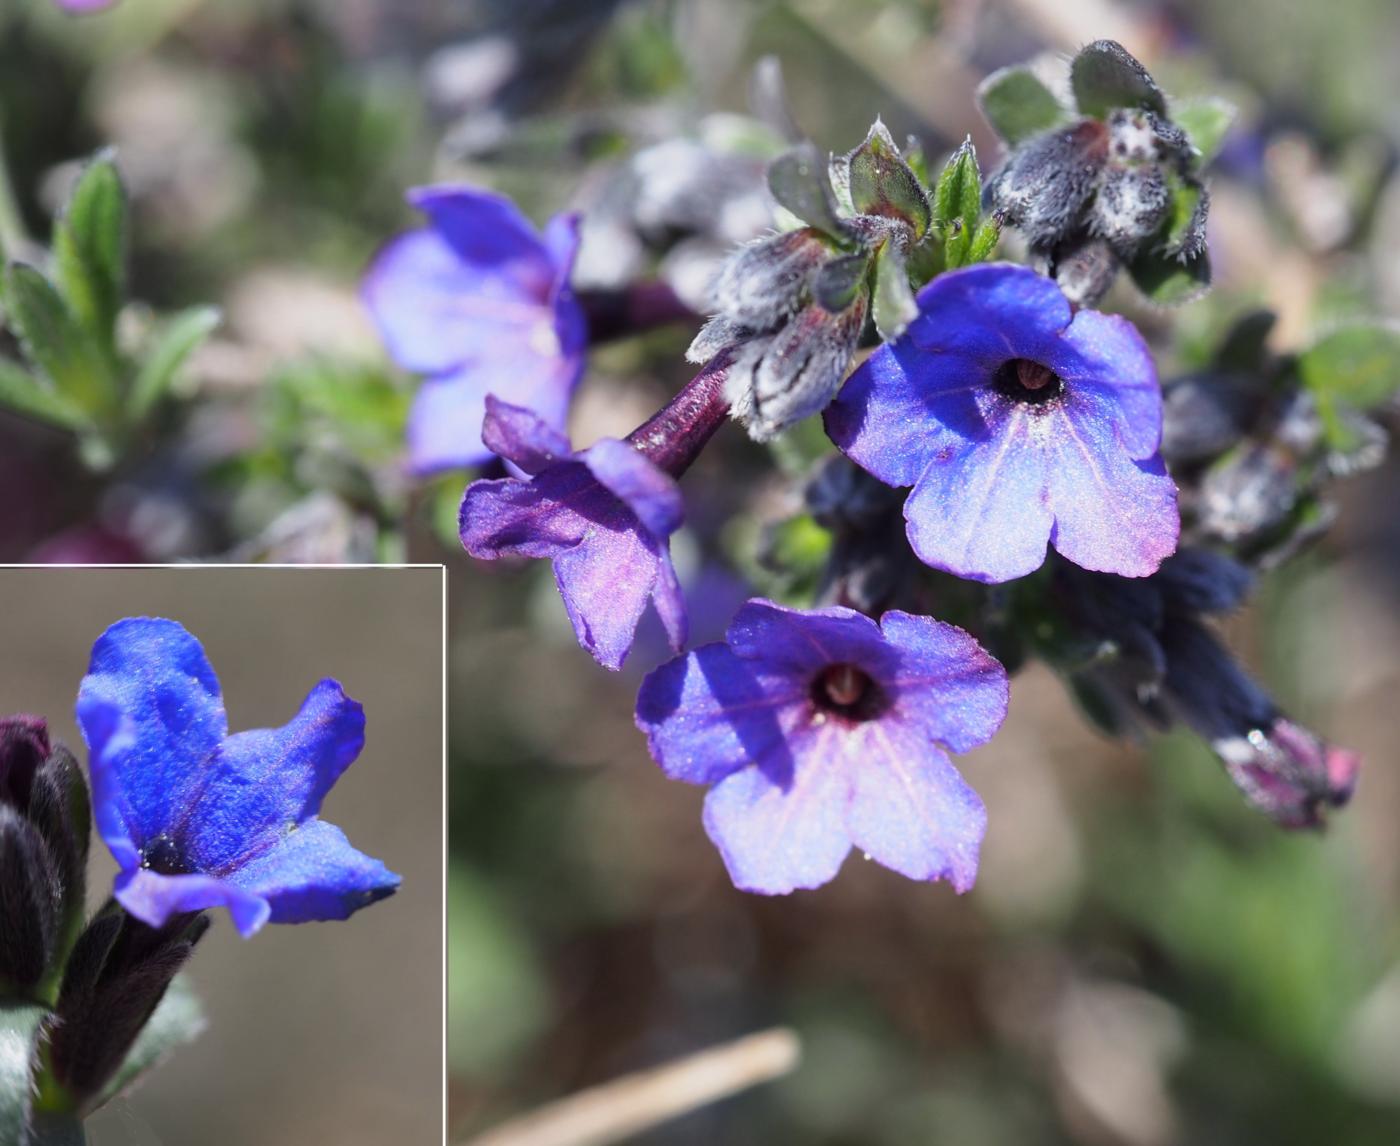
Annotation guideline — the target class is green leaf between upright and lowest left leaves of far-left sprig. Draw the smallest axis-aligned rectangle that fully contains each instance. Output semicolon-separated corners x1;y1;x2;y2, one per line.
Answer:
4;263;116;421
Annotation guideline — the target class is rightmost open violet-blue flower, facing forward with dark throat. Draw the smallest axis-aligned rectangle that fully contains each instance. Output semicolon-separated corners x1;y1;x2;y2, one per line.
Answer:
826;263;1180;582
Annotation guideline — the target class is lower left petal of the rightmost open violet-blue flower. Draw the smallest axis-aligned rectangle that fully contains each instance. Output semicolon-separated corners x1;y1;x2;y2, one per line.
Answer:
904;404;1051;582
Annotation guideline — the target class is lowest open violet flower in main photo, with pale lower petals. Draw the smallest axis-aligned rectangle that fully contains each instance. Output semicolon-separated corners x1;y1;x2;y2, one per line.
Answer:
637;600;1008;894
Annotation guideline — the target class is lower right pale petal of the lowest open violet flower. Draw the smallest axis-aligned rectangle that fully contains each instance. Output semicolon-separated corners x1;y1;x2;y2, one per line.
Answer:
839;721;987;891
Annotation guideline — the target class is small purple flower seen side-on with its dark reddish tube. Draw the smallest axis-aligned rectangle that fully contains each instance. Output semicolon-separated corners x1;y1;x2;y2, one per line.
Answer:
461;354;728;669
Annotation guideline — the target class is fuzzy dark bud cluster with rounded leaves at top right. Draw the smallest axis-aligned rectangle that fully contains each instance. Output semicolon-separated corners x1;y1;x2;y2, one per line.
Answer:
979;41;1210;305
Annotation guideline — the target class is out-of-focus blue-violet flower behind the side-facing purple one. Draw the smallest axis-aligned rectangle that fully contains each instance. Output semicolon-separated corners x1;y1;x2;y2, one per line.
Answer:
363;185;588;473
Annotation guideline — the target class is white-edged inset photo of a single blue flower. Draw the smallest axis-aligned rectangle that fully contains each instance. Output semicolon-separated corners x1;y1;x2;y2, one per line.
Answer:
0;565;445;1146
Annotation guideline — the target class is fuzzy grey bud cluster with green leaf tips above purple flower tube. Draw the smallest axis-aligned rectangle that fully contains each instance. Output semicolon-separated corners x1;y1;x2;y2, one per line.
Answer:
686;120;1000;441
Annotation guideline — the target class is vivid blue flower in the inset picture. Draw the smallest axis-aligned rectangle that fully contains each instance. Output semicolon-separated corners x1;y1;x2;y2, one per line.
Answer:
77;617;399;936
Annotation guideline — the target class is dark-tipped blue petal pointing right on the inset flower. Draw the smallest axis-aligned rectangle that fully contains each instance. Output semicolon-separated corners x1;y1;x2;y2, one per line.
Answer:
228;820;402;935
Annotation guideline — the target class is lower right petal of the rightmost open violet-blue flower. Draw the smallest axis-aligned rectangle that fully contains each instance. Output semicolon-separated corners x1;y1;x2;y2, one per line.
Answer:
1046;404;1182;576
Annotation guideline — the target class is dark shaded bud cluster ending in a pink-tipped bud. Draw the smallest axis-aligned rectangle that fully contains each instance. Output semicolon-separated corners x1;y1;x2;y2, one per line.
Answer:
1051;549;1361;827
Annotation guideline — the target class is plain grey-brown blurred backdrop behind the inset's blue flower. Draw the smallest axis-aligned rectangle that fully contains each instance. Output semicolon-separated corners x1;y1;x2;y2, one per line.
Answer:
0;568;442;1146
